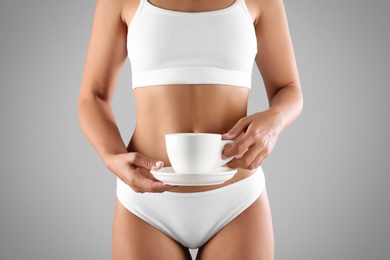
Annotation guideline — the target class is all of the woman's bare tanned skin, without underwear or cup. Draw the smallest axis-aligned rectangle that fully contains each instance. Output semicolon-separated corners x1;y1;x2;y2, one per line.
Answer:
79;0;302;260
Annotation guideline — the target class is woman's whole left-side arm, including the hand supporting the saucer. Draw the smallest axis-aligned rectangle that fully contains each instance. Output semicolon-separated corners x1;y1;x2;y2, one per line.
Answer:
78;0;170;192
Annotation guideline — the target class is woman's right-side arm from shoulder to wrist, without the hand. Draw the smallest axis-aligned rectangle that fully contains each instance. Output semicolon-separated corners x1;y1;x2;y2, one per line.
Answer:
256;0;303;128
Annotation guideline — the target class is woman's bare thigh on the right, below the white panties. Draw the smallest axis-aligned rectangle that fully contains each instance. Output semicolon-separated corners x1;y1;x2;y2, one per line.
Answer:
197;190;274;260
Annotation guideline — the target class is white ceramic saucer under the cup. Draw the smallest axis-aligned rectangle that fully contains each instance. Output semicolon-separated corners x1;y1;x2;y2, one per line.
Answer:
150;167;237;186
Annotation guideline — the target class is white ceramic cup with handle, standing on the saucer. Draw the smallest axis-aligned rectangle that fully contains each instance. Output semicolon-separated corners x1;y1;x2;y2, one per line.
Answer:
165;133;234;174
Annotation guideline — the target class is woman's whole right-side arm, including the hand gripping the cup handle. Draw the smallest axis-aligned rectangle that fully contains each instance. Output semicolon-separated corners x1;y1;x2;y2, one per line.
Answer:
224;0;303;169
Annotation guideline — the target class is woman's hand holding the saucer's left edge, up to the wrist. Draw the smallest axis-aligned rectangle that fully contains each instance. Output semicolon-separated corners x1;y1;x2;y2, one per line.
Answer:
104;153;173;193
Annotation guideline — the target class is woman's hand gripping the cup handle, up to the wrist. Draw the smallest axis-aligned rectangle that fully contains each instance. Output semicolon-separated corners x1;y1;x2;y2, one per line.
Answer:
223;109;283;170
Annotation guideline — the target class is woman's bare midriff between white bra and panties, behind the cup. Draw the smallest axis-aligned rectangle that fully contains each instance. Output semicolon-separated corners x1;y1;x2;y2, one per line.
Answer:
128;85;252;192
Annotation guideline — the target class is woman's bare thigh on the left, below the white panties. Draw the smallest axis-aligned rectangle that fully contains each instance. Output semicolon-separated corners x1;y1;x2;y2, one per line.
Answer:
112;199;191;260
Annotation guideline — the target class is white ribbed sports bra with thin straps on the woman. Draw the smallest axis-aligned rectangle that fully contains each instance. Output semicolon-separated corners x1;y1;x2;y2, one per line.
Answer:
127;0;257;88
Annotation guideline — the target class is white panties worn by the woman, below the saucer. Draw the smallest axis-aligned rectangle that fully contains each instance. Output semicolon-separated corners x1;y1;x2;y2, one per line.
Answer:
117;167;265;248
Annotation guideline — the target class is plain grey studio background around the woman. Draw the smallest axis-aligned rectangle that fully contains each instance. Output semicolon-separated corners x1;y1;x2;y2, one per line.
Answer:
0;0;390;260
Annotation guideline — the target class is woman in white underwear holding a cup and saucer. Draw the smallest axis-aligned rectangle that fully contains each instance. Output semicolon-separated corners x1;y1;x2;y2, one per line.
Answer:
79;0;302;259
